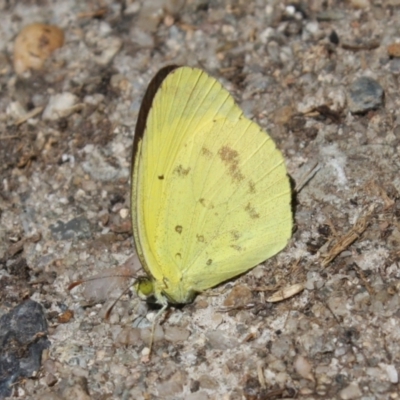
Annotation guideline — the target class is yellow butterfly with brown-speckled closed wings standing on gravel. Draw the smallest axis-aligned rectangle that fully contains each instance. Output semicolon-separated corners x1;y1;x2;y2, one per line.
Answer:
131;66;292;310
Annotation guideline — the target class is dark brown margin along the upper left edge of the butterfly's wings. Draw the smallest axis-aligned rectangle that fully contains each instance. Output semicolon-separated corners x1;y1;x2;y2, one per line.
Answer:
131;65;179;177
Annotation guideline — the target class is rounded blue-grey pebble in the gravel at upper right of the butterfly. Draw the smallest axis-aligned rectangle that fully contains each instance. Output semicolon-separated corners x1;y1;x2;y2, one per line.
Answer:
348;76;384;113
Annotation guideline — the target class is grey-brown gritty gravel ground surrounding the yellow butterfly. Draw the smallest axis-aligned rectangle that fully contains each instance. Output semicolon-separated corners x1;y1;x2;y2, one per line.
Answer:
0;0;400;400
